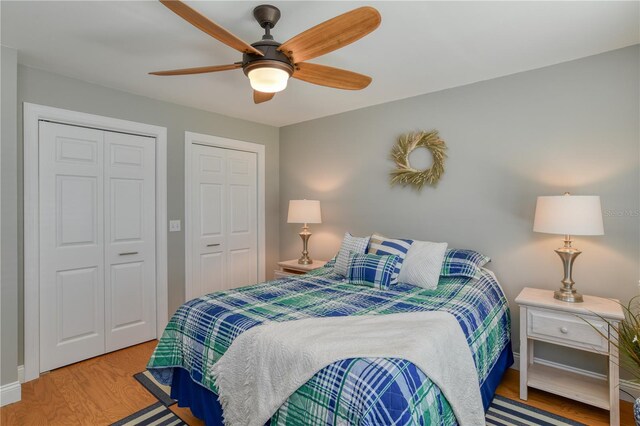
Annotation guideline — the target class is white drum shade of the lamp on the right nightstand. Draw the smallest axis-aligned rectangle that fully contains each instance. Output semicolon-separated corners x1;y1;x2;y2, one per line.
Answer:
533;195;604;235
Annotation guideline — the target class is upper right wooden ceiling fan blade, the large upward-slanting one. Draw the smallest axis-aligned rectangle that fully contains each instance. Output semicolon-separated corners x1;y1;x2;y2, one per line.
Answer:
278;6;382;63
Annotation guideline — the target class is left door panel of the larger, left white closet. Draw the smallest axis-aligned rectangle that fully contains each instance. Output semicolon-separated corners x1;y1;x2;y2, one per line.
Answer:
39;122;105;371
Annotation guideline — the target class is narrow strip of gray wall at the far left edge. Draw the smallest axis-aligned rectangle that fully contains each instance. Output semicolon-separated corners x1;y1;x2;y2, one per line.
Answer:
0;46;18;385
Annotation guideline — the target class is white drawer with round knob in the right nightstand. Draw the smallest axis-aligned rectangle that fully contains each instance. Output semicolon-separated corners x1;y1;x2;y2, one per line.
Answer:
527;308;609;352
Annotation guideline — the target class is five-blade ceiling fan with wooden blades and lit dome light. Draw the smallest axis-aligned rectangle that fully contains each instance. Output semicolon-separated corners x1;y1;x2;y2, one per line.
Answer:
149;0;381;104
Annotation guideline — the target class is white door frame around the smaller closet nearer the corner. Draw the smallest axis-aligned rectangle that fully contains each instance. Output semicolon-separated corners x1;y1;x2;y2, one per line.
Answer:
184;132;266;300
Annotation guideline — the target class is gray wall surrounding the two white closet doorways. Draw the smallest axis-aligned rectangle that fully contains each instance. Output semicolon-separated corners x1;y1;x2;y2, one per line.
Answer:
14;65;279;363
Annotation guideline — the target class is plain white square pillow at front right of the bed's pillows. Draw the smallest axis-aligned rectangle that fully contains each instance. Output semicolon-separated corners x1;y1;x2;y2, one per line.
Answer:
398;241;447;290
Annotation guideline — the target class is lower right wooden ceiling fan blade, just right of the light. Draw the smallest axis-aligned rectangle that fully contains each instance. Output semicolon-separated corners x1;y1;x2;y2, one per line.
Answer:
293;62;371;90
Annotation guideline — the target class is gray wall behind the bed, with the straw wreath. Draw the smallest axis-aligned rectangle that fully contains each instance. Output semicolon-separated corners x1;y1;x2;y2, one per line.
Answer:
280;45;640;370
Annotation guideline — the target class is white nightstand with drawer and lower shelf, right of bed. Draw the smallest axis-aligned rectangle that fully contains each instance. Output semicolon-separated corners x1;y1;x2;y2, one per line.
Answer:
516;288;624;425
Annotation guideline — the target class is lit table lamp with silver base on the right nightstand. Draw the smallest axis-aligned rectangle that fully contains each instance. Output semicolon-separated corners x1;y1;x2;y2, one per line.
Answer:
533;192;604;302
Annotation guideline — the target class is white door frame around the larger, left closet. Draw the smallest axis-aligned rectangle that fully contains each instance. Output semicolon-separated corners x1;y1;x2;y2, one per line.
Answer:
23;102;169;382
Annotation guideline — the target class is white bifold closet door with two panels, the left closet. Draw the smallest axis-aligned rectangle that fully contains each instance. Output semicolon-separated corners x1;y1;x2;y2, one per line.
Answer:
39;122;156;371
